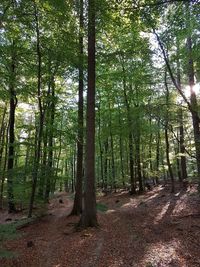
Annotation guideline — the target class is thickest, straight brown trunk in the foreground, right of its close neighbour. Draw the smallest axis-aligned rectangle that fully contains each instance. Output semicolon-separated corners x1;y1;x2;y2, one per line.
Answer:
79;0;98;228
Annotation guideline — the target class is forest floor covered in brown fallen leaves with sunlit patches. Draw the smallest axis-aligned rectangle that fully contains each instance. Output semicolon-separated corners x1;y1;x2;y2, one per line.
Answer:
0;186;200;267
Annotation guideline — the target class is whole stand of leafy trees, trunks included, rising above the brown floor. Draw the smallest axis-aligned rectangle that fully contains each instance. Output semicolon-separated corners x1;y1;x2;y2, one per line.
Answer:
0;0;200;225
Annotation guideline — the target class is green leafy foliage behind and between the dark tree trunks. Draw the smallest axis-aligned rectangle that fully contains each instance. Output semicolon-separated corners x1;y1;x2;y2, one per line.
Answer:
0;0;200;216
